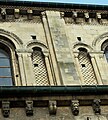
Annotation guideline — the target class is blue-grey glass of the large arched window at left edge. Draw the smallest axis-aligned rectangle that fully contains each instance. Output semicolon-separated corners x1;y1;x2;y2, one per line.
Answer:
0;48;13;86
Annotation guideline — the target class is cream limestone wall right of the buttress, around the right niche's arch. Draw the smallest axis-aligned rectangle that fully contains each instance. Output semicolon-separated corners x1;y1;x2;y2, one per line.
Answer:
65;24;108;84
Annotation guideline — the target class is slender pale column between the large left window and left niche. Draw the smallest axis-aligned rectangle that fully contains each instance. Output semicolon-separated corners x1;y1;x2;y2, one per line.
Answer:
17;53;27;86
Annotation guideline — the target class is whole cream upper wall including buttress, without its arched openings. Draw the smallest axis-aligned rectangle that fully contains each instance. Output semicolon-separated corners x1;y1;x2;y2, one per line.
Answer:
0;11;108;85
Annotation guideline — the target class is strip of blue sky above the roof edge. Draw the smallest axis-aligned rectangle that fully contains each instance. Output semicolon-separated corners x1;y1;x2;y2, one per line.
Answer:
19;0;108;5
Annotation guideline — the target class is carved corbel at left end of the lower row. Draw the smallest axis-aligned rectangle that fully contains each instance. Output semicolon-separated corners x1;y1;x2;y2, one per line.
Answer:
2;101;10;117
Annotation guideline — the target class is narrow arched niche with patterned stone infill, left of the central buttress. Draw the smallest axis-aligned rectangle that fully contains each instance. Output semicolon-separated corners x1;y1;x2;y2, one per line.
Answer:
32;47;49;86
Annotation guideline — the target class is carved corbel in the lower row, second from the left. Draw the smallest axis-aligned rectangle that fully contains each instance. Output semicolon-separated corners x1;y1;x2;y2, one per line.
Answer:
26;101;33;116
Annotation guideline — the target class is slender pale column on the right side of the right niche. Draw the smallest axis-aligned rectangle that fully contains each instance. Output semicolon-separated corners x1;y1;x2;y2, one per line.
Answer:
90;53;103;85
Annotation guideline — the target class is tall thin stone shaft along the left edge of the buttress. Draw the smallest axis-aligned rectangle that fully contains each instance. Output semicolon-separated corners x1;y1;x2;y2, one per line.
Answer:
42;12;61;85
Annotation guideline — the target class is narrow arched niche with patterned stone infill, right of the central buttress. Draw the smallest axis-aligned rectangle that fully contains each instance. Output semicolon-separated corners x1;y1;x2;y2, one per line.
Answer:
78;48;97;85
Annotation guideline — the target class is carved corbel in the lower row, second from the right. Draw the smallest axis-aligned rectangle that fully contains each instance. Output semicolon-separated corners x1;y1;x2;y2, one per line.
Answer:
71;100;79;116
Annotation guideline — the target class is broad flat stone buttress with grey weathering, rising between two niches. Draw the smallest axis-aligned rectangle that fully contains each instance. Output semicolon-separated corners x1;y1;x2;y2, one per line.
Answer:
46;11;79;85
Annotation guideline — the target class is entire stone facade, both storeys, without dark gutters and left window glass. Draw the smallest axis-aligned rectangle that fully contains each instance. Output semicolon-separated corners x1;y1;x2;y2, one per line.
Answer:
0;2;108;120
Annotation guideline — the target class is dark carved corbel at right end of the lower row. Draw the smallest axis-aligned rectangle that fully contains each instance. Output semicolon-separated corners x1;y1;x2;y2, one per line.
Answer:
92;99;101;114
